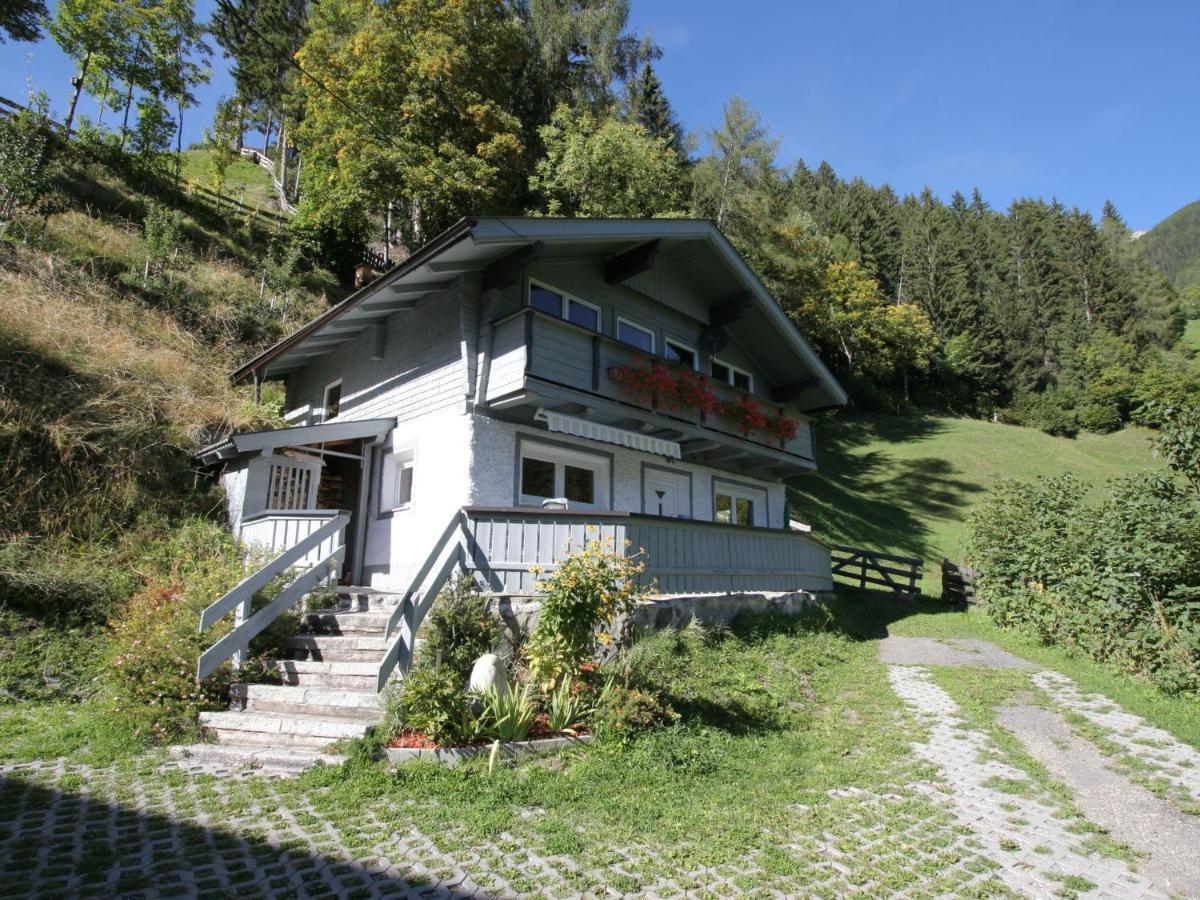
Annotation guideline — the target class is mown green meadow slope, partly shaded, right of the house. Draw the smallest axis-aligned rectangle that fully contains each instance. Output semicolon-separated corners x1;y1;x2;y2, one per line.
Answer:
791;415;1159;592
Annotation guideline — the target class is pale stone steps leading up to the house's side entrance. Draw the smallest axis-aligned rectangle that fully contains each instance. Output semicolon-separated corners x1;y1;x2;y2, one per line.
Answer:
173;588;401;774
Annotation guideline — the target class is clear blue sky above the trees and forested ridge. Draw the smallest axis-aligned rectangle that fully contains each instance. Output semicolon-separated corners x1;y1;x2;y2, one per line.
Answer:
0;0;1200;228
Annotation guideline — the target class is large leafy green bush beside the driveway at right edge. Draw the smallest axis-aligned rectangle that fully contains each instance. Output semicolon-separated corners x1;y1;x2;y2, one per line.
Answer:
968;465;1200;692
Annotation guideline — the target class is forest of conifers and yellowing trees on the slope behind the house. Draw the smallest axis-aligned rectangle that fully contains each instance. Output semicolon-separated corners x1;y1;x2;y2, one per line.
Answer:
8;0;1200;434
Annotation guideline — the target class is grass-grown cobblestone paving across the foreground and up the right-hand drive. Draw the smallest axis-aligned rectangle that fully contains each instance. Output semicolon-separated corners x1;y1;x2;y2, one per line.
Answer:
0;638;1200;898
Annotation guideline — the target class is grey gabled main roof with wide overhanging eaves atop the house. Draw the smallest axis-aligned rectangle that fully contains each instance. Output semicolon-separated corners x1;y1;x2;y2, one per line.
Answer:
232;217;847;408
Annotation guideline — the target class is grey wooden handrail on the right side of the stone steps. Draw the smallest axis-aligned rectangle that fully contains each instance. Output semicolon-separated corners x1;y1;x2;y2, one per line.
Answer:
376;510;478;691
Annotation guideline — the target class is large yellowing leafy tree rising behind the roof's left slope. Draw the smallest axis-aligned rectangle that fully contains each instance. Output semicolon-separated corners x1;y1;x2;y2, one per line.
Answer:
296;0;535;256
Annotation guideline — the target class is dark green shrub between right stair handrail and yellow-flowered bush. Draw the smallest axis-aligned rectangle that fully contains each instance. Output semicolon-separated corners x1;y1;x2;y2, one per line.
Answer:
420;576;502;686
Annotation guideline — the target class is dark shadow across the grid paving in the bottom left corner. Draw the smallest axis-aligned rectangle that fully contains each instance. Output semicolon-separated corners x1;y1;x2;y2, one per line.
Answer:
0;774;474;899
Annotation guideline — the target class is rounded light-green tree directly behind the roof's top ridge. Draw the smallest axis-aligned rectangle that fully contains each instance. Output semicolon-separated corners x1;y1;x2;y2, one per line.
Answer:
529;106;683;217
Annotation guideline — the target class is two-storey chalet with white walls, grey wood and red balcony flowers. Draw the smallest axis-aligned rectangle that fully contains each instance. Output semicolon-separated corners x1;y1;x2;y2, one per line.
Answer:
200;217;846;710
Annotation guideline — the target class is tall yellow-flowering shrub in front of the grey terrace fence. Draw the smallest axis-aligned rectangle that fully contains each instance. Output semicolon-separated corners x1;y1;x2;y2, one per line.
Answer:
526;540;646;690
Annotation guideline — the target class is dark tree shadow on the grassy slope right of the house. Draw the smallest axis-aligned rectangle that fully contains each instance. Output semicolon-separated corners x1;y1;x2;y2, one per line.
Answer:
790;415;983;562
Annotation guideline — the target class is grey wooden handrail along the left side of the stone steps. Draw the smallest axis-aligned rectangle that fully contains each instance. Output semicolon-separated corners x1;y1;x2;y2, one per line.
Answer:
196;510;350;679
